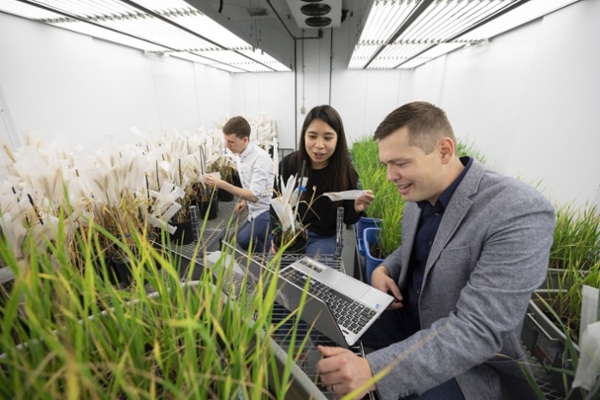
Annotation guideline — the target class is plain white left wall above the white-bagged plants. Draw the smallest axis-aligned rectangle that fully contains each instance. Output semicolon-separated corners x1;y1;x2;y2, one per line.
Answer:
0;13;232;151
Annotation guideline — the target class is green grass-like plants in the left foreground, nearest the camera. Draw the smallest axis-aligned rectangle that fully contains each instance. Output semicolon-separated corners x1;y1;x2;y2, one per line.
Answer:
0;214;314;399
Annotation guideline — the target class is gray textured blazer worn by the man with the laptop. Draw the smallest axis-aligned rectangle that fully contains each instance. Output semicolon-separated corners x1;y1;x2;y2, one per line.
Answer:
367;160;554;400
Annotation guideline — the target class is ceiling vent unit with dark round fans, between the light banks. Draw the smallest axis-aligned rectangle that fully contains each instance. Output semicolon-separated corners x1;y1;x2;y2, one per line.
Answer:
286;0;342;29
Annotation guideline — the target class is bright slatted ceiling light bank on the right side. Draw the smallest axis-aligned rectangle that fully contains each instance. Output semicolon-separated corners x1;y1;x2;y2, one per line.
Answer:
348;0;579;69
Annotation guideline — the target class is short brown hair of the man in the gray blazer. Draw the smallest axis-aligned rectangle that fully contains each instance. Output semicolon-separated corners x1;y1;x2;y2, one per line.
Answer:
373;101;456;154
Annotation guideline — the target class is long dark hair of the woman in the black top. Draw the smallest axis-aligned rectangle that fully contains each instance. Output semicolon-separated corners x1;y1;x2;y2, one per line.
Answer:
290;105;357;194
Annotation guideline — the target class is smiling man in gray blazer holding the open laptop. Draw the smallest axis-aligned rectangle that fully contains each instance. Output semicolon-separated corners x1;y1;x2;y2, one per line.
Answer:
317;102;554;400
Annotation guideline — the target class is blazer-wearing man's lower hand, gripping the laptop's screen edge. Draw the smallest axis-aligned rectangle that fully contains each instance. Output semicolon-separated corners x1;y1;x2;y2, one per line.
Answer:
316;346;376;399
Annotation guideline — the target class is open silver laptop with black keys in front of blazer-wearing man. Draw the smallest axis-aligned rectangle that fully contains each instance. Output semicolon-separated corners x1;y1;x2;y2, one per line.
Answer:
219;242;393;348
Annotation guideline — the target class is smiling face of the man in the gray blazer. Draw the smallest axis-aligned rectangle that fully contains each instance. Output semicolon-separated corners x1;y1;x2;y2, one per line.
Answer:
379;127;445;204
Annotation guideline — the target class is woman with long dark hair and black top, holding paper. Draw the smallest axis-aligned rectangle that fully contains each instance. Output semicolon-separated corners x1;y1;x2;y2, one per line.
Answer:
273;105;374;256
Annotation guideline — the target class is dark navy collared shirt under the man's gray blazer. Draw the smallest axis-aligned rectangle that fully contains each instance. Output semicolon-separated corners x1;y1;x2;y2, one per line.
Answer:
403;157;473;335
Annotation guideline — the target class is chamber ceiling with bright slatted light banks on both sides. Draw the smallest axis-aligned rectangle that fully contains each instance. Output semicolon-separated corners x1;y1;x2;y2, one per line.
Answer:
0;0;578;72
